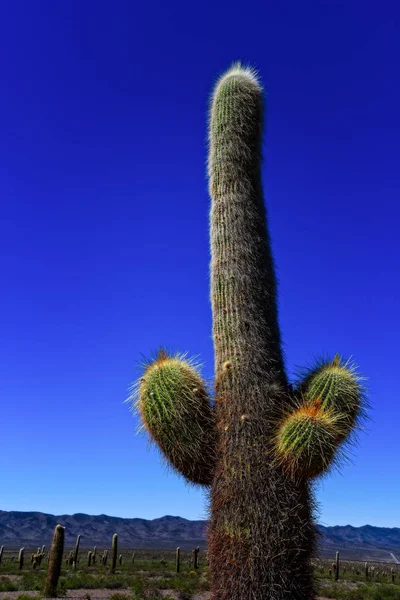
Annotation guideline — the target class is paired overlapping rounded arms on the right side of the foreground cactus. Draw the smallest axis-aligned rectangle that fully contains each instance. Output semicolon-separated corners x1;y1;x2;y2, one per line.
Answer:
275;354;366;478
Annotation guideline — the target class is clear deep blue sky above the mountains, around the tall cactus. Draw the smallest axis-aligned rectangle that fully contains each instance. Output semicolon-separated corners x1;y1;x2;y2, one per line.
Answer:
0;0;400;526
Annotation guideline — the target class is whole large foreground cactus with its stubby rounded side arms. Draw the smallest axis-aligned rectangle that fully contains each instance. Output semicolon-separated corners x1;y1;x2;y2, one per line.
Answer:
131;64;364;600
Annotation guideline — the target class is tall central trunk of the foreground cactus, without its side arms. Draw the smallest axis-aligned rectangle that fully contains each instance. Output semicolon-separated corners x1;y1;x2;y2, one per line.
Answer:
208;65;315;600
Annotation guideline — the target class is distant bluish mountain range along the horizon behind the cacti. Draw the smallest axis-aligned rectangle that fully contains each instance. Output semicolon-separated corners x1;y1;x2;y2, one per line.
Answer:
0;511;400;562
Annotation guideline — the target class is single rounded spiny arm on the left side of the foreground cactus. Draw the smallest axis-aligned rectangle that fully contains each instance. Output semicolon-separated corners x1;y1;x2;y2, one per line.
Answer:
132;349;216;485
